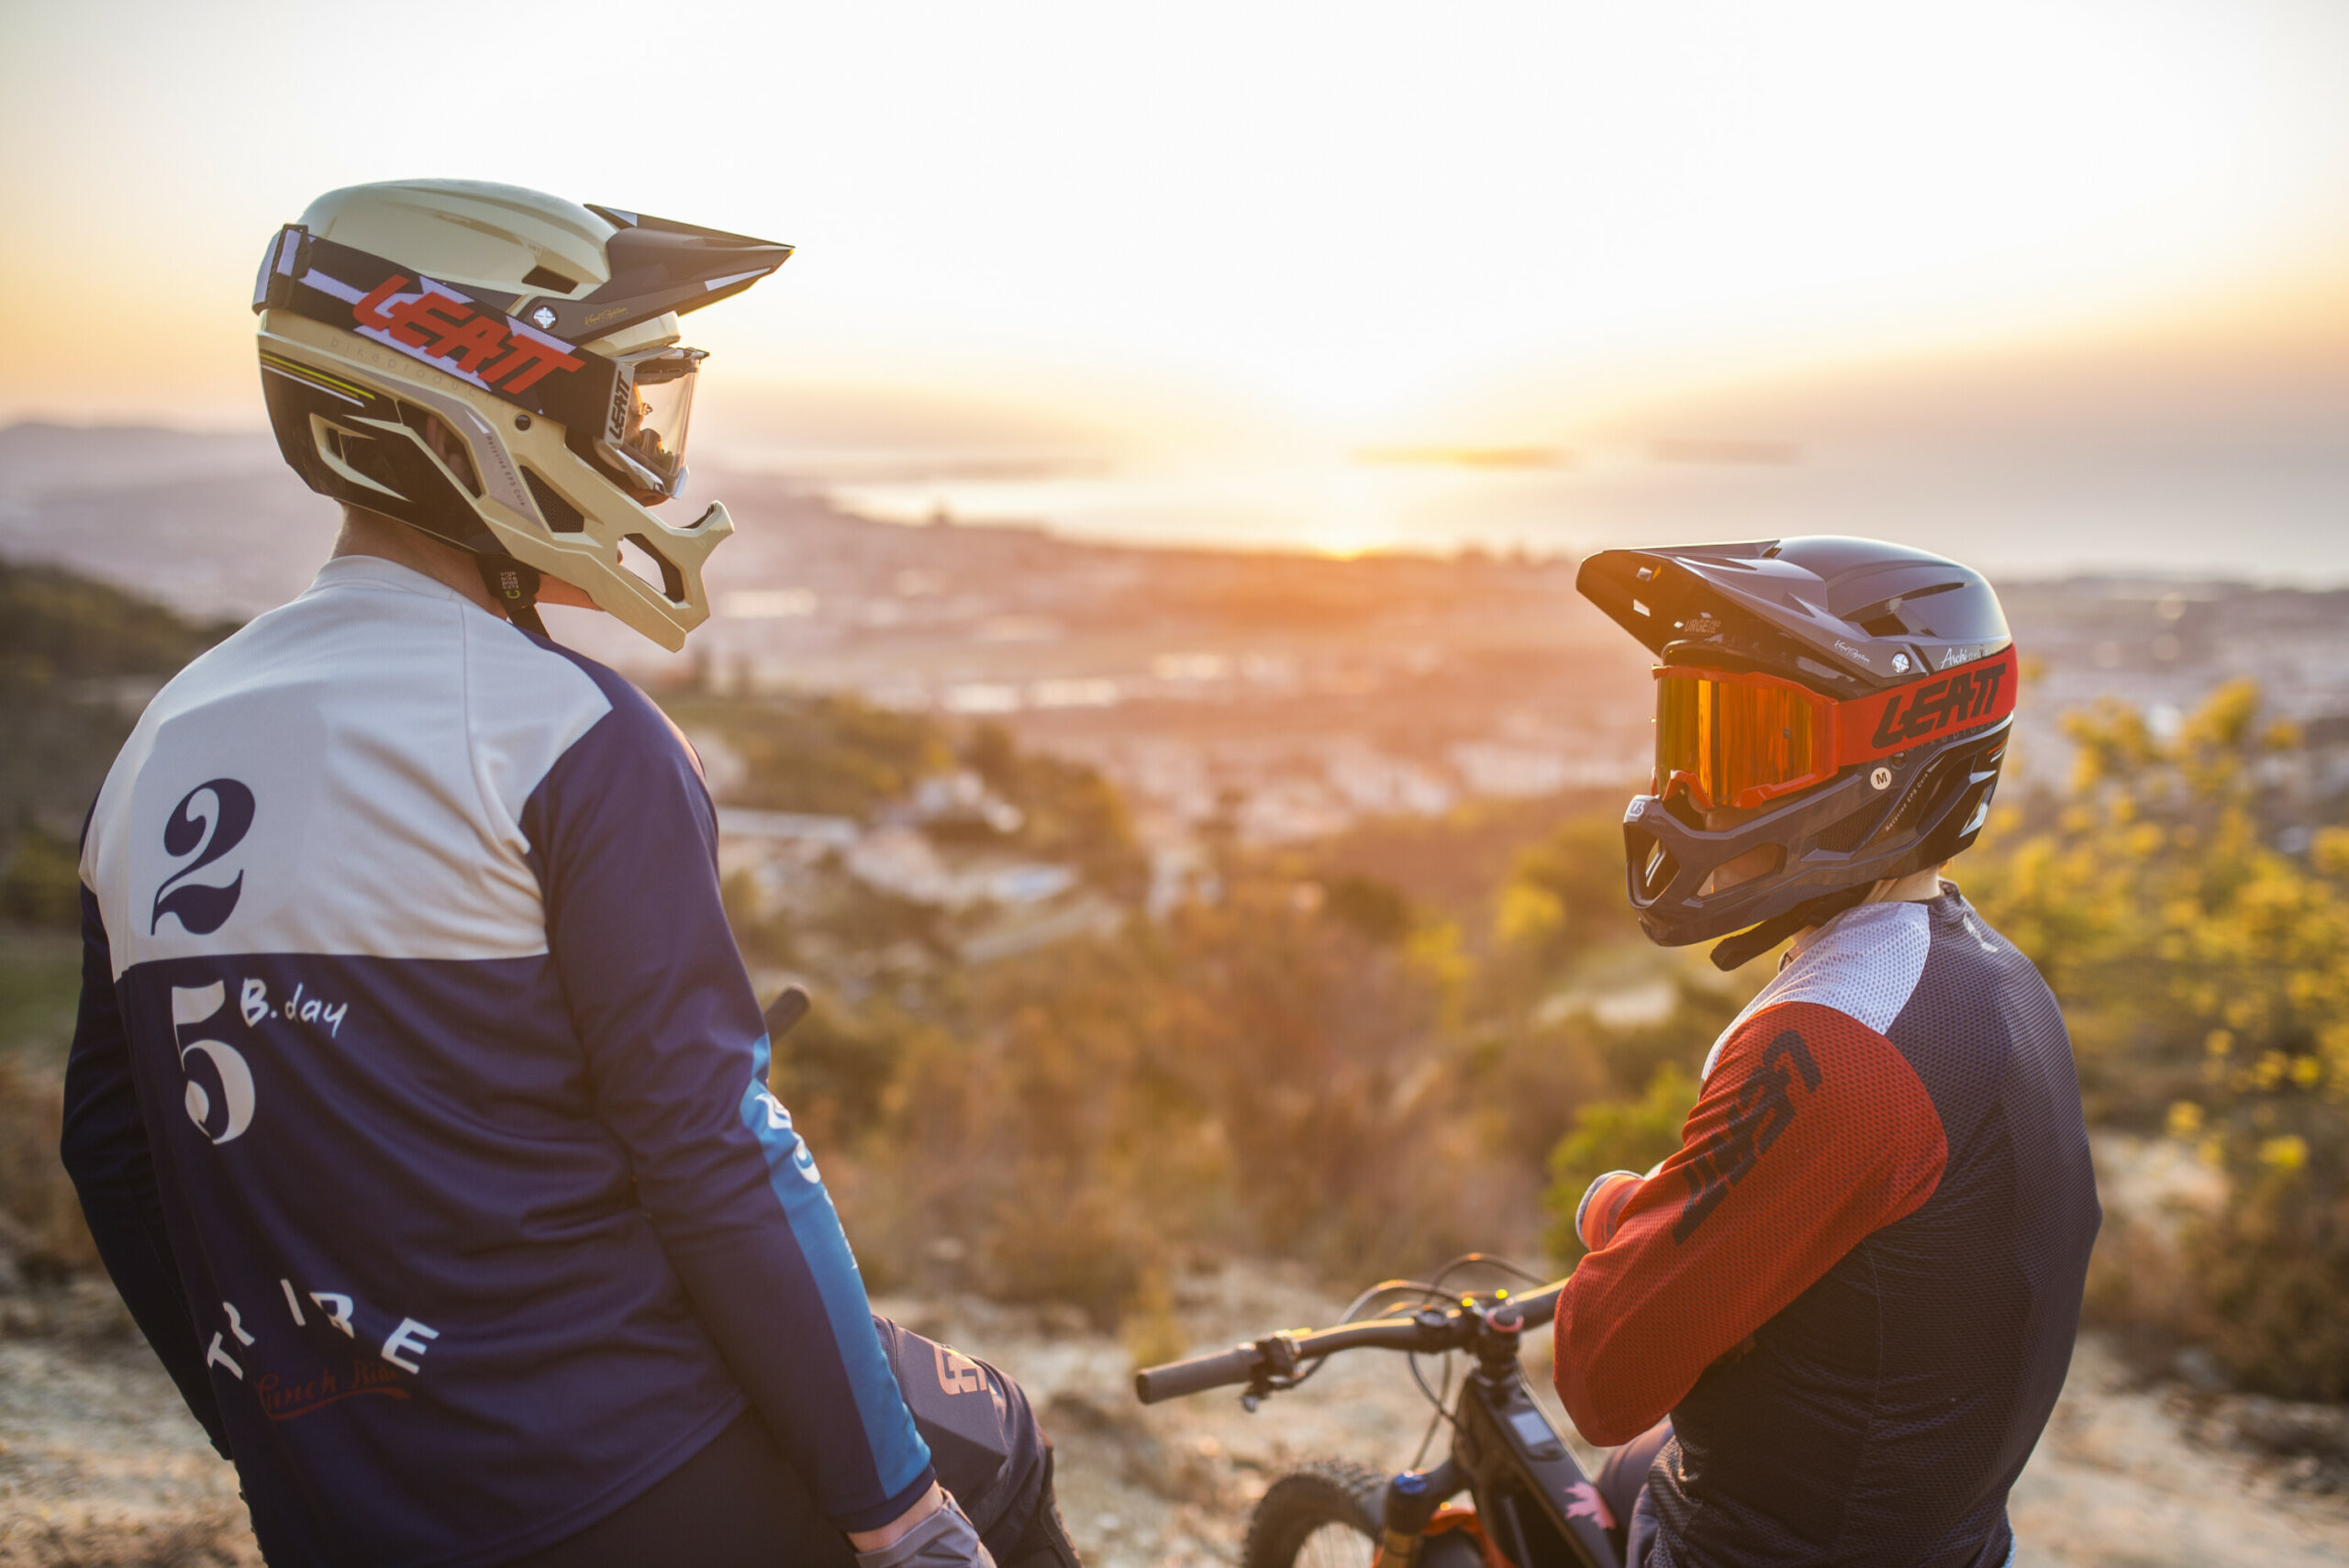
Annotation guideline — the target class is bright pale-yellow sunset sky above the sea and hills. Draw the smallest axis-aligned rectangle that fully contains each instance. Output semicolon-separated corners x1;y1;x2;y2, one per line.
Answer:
0;0;2349;575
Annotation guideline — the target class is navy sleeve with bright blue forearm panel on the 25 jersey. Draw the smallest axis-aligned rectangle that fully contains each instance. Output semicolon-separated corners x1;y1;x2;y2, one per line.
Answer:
521;672;935;1530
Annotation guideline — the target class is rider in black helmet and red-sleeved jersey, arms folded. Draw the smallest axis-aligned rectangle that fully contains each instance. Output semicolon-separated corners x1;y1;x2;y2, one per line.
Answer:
1557;538;2100;1568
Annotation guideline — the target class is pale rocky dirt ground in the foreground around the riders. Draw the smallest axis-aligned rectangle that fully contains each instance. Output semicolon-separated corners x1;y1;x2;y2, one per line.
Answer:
0;1268;2349;1568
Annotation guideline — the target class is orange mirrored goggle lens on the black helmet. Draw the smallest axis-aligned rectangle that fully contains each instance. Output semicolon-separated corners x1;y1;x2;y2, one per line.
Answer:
1656;669;1834;810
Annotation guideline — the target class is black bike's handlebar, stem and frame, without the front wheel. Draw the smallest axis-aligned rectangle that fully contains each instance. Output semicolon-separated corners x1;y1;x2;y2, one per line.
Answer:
1134;1286;1620;1568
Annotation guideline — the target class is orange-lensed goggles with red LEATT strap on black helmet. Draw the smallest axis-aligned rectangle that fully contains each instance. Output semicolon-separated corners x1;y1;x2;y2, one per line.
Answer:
1656;643;2015;812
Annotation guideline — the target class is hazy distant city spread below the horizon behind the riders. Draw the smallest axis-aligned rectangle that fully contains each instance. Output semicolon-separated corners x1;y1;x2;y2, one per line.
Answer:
0;425;2349;882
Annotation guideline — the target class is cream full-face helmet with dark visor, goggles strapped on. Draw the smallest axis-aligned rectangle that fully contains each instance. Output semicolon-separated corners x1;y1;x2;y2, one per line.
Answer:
253;181;792;652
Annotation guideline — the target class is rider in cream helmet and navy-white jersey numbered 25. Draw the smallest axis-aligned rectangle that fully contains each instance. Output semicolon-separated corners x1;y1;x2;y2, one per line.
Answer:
63;181;1074;1568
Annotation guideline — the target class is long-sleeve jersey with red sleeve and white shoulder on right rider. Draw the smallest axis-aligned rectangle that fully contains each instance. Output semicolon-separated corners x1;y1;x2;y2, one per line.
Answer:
1557;883;2100;1568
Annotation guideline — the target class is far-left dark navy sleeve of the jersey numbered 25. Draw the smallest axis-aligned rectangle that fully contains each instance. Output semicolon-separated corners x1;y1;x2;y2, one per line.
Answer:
59;887;228;1458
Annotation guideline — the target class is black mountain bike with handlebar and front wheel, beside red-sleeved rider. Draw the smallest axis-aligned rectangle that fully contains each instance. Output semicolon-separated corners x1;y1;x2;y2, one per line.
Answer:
1134;1253;1620;1568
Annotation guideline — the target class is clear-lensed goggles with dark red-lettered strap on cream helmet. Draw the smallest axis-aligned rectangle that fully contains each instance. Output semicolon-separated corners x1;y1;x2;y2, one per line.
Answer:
253;223;705;502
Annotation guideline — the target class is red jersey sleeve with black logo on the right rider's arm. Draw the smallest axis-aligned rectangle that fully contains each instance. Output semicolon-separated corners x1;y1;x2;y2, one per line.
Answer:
1555;1002;1947;1443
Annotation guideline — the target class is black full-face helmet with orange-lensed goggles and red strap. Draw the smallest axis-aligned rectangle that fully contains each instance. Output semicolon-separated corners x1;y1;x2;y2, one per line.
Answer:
1574;535;2018;970
